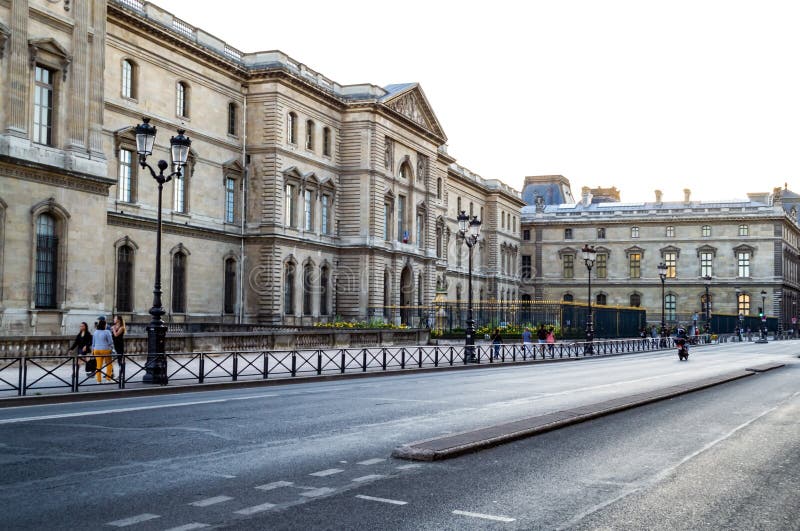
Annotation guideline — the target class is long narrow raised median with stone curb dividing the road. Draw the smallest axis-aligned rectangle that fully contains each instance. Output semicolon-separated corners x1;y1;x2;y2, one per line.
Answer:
392;363;784;461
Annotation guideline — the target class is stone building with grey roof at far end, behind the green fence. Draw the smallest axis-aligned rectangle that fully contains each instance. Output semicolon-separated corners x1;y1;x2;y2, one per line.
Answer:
521;176;800;328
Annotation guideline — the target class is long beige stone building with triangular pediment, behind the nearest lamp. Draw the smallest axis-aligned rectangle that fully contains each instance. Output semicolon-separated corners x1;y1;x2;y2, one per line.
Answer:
0;0;523;334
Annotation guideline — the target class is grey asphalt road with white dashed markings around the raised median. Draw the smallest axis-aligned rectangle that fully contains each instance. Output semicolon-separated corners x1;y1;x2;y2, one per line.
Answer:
0;342;800;530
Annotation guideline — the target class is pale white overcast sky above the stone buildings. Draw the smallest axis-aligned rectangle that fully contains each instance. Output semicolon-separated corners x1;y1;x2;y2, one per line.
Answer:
154;0;800;202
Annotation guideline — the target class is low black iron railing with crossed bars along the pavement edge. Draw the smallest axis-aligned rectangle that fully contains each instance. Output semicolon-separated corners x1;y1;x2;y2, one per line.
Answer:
0;338;688;397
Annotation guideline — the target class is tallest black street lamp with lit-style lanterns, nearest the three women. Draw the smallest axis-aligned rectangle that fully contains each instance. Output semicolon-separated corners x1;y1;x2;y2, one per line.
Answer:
136;117;192;385
